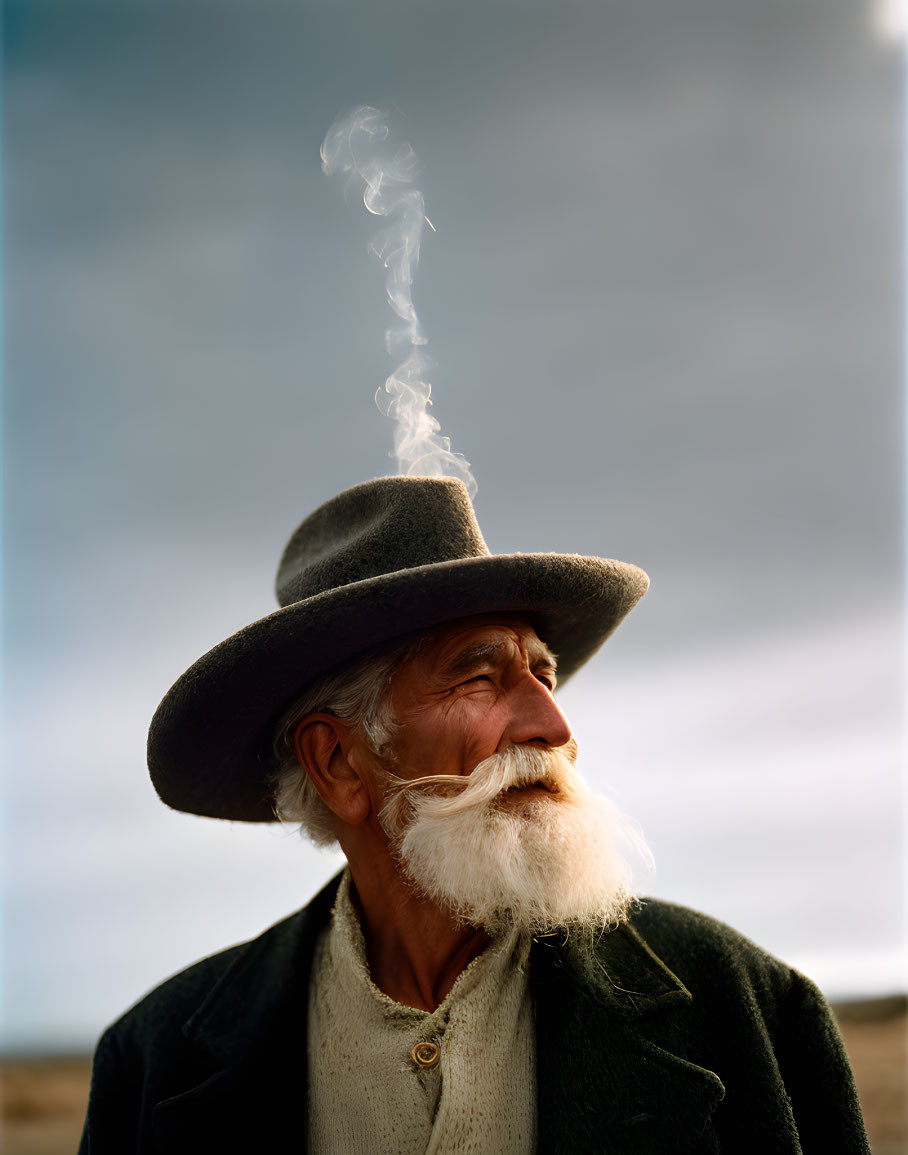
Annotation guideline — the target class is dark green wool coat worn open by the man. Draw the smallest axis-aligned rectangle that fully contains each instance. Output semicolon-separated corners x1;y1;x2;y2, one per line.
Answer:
81;879;869;1155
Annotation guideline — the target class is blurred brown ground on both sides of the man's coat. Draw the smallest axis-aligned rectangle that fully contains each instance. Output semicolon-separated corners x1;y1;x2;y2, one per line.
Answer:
0;997;908;1155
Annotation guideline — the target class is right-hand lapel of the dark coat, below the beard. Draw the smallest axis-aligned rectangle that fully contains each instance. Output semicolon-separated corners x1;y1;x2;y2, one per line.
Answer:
530;925;724;1155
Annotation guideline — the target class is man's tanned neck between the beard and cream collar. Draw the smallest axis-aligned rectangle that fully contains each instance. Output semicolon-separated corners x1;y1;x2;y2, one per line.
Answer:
348;854;489;1011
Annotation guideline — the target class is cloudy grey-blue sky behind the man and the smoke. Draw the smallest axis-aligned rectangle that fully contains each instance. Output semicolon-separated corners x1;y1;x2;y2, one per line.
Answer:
0;0;903;1050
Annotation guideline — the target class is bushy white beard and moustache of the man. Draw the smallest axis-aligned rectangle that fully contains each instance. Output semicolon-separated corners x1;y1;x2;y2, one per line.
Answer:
380;743;652;934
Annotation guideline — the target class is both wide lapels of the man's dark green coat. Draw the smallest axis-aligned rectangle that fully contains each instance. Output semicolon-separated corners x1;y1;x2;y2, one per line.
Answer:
155;877;724;1155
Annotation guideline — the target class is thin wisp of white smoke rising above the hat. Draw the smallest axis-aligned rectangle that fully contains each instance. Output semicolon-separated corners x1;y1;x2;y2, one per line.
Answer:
321;106;476;497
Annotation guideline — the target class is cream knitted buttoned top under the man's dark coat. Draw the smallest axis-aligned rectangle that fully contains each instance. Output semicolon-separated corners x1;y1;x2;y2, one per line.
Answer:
307;872;536;1155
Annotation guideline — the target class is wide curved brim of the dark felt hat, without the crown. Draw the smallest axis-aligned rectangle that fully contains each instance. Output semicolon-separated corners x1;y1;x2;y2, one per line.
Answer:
148;553;649;822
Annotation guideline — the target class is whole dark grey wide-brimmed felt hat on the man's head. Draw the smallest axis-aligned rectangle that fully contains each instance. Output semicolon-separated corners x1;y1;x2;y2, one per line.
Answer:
148;477;649;822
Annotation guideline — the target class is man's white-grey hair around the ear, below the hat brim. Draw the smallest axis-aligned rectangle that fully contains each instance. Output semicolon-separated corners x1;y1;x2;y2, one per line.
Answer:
271;635;422;847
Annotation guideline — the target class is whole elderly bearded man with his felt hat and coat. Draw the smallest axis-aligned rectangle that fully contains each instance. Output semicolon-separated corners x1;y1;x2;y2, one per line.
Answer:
82;478;868;1155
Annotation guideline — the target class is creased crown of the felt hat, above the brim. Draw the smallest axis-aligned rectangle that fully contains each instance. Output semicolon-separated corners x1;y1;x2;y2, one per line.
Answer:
275;477;489;606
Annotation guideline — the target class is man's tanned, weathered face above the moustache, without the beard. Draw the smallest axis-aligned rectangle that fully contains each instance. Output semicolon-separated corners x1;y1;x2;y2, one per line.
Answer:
392;614;571;778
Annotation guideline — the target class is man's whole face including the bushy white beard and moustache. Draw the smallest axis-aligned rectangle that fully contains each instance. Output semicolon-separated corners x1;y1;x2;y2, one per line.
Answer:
367;614;634;933
